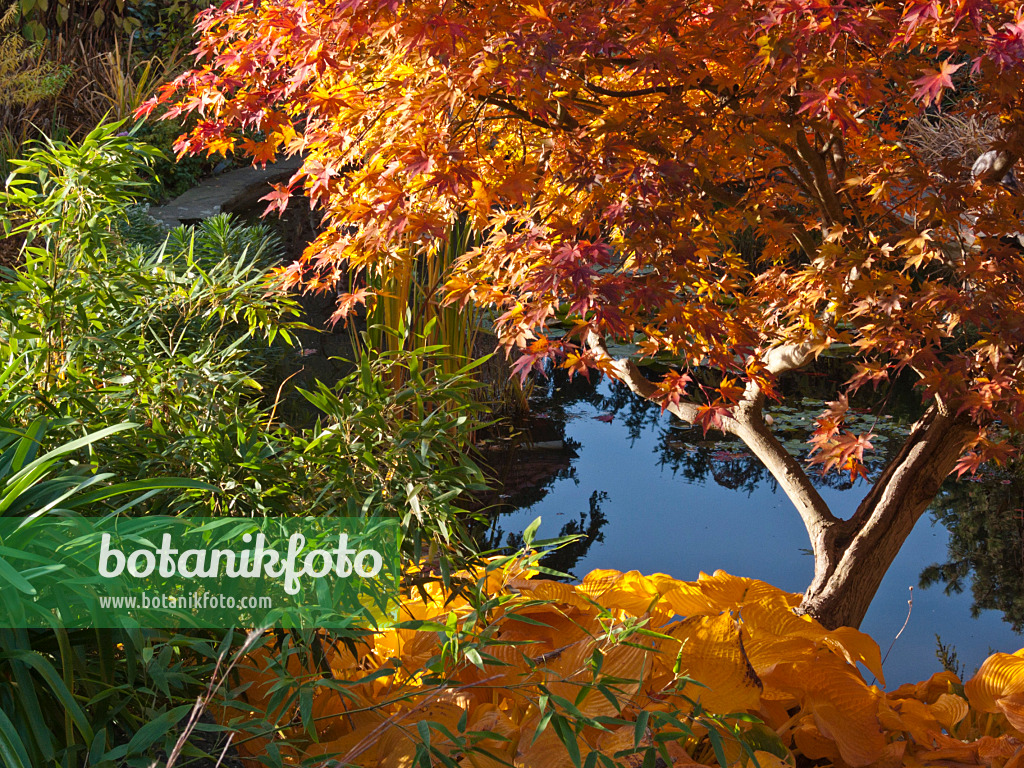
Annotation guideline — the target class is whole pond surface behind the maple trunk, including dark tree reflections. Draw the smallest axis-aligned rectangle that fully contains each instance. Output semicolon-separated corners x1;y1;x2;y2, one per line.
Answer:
490;370;1024;688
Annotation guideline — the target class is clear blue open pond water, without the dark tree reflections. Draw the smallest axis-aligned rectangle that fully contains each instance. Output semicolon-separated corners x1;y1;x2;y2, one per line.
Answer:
494;376;1024;689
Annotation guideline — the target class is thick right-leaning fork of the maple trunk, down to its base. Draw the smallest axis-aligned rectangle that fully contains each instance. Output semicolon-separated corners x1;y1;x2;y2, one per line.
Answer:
800;404;977;628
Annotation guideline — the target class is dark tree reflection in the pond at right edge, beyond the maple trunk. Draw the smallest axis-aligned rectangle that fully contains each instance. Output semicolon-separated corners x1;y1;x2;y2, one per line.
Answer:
921;467;1024;632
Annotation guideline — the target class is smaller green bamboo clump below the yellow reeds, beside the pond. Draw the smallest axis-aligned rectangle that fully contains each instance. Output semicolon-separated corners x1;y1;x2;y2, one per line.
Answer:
292;335;493;567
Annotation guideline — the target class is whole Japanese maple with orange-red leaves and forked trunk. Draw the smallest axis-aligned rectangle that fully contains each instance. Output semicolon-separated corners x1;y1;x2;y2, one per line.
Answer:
149;0;1024;627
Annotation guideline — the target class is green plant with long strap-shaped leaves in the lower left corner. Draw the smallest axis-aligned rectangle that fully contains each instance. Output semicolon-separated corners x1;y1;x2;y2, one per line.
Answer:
0;385;228;768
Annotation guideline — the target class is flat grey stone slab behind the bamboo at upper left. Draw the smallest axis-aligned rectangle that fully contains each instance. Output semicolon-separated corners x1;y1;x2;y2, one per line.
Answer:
150;157;302;226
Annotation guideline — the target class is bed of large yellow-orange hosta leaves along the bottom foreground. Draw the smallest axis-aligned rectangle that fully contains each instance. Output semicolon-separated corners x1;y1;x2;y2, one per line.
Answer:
216;562;1024;768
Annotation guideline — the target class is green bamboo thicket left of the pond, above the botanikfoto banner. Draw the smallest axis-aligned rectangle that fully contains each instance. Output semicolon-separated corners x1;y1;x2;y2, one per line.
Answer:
0;124;491;556
